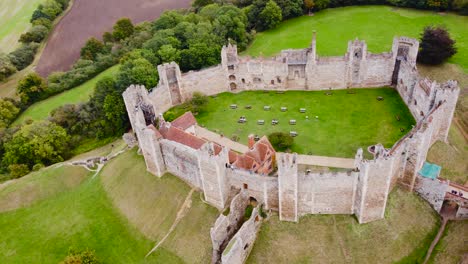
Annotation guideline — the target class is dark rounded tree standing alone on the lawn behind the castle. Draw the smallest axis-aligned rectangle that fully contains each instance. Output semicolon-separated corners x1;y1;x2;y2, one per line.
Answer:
418;26;457;65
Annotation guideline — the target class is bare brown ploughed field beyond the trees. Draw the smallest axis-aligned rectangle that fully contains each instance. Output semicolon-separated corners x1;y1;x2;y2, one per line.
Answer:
36;0;192;76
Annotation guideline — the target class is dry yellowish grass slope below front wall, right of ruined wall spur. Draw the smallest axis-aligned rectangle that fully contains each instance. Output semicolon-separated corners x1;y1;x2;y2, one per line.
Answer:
247;189;440;263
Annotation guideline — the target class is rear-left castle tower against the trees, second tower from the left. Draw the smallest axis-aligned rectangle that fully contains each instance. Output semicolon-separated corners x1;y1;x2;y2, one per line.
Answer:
158;62;184;105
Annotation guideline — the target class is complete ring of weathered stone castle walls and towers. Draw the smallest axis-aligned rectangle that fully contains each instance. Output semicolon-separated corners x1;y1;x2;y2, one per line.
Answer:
123;34;460;223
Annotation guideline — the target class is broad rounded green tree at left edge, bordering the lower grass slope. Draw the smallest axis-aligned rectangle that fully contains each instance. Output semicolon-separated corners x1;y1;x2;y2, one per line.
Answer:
3;121;70;168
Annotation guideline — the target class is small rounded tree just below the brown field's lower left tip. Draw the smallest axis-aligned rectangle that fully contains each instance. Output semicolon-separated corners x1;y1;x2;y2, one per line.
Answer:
16;73;47;104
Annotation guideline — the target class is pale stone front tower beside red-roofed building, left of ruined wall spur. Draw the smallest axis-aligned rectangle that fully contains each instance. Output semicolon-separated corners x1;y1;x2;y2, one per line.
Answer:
198;142;229;209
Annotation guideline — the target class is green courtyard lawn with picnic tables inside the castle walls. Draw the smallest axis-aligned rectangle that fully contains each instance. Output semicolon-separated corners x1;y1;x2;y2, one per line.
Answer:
171;88;414;157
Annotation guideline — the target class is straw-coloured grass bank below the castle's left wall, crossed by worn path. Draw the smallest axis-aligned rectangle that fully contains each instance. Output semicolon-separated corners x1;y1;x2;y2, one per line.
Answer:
102;150;219;263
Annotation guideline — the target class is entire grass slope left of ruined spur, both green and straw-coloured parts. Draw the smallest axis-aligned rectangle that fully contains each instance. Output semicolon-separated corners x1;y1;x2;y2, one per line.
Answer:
0;148;218;263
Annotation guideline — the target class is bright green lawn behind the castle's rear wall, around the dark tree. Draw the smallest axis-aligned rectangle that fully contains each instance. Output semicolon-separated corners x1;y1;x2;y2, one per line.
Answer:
244;6;468;72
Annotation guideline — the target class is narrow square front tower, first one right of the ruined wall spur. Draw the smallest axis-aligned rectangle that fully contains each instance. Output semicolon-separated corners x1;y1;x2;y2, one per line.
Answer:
277;153;299;222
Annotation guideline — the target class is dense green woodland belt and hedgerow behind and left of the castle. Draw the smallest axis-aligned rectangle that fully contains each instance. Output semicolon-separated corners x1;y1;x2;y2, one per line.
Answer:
0;0;462;177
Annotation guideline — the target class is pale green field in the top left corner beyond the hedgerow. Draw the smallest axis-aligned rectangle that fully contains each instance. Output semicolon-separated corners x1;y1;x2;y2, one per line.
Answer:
0;0;44;53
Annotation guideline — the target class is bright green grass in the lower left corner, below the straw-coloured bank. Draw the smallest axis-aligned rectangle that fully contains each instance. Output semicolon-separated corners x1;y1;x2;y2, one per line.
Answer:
0;174;178;263
